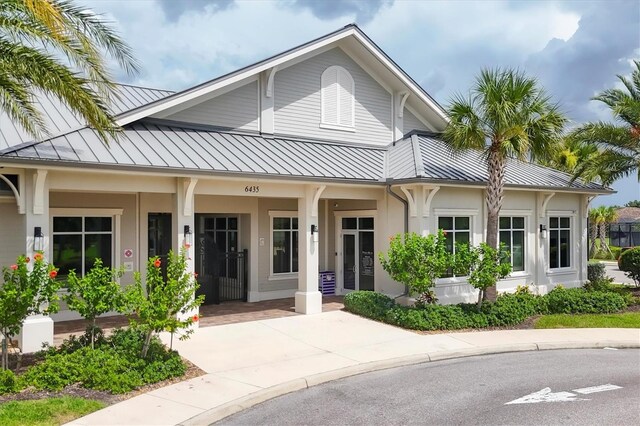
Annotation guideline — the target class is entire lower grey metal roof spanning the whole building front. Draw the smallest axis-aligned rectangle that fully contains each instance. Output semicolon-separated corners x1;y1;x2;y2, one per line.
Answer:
0;125;611;193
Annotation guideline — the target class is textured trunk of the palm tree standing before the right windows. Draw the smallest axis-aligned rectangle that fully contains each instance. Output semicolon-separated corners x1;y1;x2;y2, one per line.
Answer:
483;148;505;300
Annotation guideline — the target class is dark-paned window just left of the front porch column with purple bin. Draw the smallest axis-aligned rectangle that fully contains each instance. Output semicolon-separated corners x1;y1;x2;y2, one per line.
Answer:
271;216;298;274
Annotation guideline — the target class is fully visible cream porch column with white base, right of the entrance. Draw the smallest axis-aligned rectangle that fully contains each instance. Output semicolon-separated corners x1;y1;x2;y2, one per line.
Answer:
295;185;325;314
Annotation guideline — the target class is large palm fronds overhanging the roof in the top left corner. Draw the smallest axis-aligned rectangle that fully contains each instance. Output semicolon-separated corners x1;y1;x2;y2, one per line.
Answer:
0;0;138;142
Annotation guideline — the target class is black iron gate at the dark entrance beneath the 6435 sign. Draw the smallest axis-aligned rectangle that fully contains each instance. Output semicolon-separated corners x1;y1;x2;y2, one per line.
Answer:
197;250;249;305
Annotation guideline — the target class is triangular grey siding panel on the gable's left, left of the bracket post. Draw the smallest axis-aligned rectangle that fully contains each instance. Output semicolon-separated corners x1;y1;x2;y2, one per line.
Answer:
166;81;258;130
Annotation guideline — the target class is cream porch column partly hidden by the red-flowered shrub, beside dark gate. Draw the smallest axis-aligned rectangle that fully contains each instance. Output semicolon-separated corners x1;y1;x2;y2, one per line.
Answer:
173;178;200;329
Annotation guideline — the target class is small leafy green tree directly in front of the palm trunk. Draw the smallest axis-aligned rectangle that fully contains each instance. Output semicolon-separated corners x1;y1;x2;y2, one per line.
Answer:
464;243;512;309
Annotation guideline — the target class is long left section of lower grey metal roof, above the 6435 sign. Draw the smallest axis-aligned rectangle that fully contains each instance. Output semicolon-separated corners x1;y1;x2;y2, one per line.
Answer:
1;122;385;181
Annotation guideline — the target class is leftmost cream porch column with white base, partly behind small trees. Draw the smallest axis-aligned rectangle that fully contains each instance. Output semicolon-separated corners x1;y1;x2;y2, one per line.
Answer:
16;169;53;353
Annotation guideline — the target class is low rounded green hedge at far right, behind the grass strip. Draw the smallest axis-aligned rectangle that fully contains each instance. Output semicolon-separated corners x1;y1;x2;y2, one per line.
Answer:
544;287;627;314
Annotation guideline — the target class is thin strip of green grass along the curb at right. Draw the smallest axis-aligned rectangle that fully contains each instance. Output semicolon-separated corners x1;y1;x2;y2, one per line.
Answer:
535;312;640;328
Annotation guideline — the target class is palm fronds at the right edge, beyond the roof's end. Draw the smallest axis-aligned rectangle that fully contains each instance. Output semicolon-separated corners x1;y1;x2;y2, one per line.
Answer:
572;61;640;185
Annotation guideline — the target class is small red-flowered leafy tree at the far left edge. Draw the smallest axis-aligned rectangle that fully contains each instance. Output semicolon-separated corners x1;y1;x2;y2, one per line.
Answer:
0;253;60;369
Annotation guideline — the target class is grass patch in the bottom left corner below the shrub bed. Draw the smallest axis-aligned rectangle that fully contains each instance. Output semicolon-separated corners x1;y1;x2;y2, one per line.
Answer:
0;397;106;426
